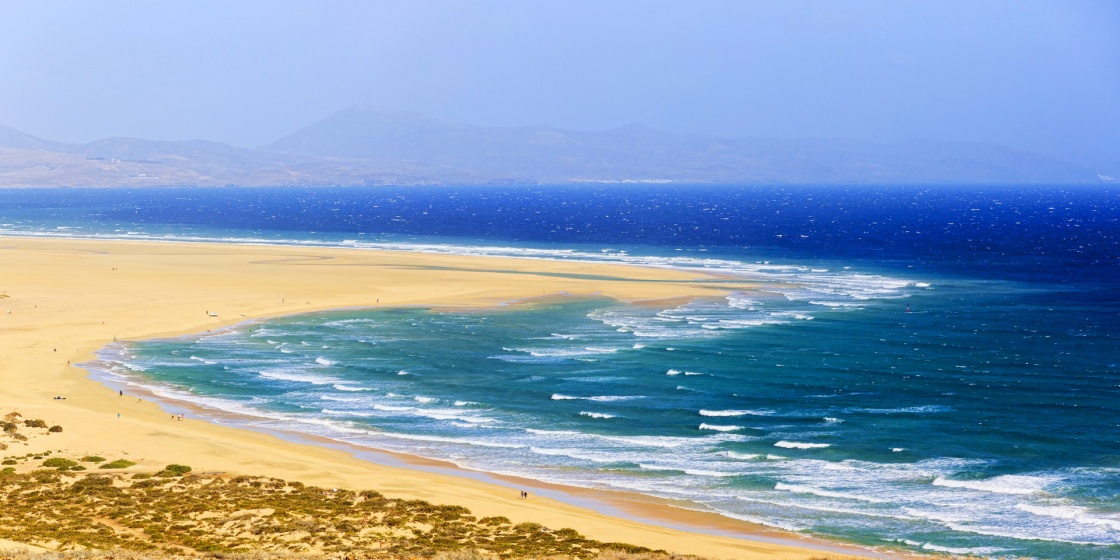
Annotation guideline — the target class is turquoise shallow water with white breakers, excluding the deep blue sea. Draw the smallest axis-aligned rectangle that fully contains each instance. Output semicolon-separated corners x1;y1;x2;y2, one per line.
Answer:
91;269;1120;558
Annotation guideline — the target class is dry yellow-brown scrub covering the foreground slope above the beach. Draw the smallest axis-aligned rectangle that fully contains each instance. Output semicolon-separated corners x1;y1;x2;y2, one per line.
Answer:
0;469;689;560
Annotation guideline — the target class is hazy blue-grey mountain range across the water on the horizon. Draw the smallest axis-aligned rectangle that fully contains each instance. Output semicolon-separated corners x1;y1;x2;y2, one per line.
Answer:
0;105;1101;187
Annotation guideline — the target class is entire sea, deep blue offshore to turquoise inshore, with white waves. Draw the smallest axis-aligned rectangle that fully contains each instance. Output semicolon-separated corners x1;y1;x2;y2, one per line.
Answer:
0;186;1120;559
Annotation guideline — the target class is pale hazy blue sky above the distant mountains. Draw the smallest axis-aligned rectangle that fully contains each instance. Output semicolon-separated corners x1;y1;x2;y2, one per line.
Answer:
0;0;1120;177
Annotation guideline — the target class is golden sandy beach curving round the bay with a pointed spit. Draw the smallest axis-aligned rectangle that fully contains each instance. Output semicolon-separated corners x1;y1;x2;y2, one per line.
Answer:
0;237;882;559
